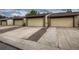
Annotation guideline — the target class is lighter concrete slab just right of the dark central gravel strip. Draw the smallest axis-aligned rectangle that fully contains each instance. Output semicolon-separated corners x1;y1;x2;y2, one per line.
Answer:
38;28;58;47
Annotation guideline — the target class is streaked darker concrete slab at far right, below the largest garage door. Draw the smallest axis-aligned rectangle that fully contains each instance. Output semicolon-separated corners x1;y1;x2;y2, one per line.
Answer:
57;28;79;50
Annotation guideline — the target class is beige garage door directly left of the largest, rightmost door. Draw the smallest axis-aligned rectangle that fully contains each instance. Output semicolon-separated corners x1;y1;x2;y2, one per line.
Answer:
28;18;43;26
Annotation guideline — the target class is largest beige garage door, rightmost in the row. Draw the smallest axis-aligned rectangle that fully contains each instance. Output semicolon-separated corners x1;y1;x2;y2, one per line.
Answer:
51;18;73;27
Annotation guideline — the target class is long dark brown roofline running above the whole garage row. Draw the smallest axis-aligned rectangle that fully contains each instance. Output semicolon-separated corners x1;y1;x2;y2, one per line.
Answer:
1;12;79;20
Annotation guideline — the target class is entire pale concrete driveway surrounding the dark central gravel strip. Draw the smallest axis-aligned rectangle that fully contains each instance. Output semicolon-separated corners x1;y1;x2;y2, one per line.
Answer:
0;27;79;50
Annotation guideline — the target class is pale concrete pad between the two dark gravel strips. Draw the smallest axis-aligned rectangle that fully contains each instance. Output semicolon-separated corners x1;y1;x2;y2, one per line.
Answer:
1;27;42;39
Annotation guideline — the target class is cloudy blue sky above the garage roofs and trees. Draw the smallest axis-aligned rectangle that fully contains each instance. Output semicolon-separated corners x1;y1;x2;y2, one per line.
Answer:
0;9;79;17
